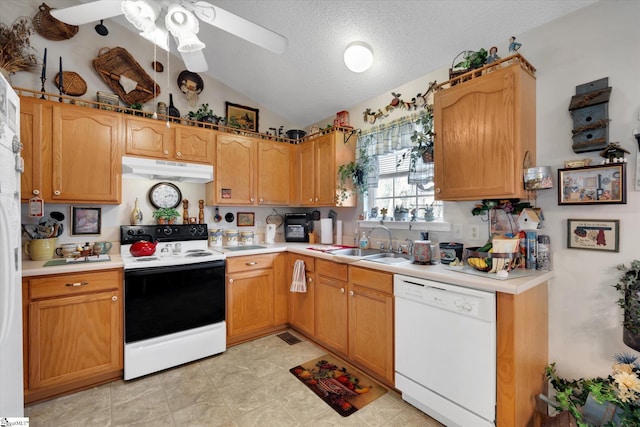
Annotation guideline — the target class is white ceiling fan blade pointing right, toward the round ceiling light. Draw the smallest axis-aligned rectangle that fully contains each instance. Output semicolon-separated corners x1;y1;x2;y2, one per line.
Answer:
183;0;289;53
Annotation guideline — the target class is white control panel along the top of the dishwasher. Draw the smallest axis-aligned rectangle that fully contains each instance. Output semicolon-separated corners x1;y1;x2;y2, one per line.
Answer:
393;274;496;321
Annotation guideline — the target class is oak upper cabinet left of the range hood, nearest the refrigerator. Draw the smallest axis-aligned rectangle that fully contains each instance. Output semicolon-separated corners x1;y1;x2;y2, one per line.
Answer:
20;97;122;204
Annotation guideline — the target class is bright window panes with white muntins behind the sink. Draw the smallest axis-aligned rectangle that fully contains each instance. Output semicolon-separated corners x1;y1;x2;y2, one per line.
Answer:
365;149;442;221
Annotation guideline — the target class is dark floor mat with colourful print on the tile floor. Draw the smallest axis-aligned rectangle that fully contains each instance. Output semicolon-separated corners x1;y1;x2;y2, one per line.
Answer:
289;354;387;417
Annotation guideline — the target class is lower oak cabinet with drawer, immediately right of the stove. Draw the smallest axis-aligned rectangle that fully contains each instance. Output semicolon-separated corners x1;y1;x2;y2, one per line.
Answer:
227;254;287;344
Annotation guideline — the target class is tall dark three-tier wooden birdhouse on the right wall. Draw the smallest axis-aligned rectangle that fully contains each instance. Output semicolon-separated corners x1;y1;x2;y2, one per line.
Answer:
569;77;611;153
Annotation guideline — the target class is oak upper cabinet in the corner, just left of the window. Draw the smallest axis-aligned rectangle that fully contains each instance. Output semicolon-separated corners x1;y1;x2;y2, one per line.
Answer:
295;131;356;207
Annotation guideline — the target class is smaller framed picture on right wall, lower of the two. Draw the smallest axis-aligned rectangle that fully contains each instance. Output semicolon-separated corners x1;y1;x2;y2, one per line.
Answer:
567;219;620;252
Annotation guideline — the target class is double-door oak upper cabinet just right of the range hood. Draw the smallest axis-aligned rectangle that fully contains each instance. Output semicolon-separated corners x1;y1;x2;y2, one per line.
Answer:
207;134;291;206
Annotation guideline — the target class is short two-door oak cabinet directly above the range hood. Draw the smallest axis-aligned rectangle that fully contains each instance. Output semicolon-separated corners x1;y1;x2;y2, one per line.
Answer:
125;116;215;165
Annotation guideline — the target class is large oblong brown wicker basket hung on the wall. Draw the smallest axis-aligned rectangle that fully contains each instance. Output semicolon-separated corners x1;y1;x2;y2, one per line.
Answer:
93;47;160;105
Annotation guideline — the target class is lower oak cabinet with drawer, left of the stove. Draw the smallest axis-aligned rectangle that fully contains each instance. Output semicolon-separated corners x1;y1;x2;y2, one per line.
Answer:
22;269;123;403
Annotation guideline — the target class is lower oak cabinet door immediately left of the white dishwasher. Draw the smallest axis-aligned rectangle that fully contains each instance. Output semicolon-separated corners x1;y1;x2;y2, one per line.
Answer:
348;285;394;383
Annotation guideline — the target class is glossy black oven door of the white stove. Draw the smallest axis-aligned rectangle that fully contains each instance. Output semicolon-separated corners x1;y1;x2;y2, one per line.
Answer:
124;260;225;343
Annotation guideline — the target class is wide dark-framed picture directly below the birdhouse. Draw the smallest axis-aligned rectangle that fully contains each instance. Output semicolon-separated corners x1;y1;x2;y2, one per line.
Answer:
558;163;627;205
